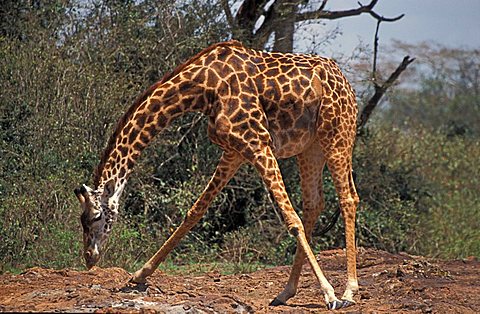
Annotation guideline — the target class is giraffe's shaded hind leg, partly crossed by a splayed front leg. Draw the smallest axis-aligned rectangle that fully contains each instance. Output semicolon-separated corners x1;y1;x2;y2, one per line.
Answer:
270;144;325;305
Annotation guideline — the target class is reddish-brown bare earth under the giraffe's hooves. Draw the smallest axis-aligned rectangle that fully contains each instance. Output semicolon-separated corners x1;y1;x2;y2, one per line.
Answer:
0;249;480;314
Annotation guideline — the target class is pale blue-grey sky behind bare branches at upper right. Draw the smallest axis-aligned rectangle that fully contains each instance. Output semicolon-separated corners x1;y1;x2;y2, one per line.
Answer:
298;0;480;53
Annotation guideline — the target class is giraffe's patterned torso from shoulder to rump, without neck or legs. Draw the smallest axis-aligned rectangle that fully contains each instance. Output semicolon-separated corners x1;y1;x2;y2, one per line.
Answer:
188;43;356;158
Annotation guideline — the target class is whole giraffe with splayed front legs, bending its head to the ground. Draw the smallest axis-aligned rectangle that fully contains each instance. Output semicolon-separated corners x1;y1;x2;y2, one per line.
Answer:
75;40;359;309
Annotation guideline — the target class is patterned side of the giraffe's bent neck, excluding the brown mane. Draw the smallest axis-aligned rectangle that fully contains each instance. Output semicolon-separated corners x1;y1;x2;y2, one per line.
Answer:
95;81;206;205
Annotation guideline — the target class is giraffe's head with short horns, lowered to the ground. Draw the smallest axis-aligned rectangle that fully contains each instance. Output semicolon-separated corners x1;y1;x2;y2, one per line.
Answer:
75;185;117;269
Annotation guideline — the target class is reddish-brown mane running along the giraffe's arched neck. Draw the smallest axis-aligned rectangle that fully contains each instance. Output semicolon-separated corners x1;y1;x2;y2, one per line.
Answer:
93;40;243;188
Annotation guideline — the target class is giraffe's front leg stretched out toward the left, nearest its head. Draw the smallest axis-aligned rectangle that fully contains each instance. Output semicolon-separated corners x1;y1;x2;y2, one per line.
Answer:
131;152;243;283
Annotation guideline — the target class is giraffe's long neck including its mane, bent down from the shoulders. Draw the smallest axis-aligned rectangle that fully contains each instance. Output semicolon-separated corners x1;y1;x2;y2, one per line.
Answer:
94;41;248;209
